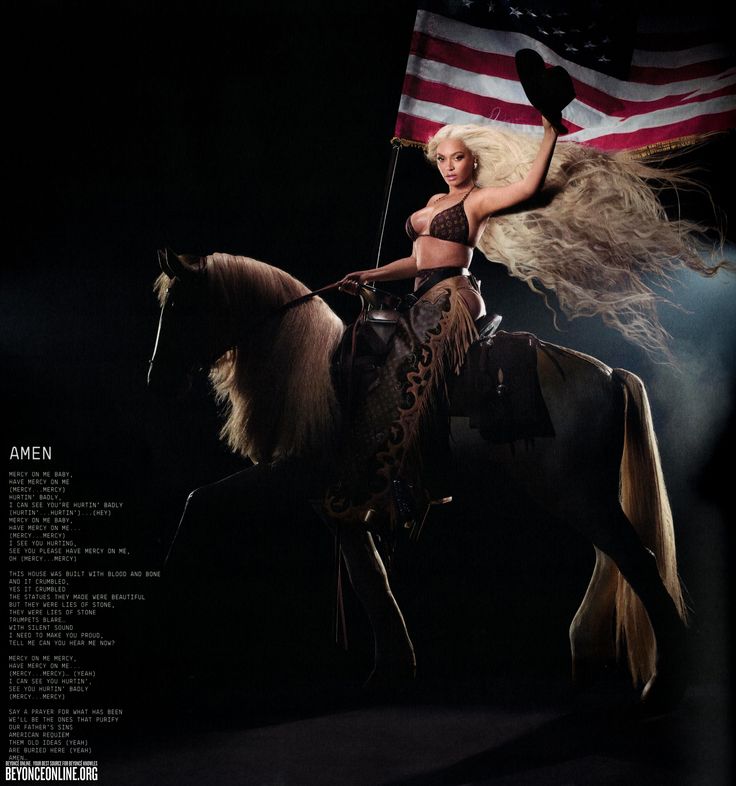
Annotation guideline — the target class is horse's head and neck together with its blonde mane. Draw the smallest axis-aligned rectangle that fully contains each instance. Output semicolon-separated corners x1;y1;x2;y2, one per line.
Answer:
148;250;344;461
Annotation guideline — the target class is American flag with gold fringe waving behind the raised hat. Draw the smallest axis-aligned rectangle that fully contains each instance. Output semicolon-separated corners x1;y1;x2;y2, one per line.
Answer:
395;0;736;150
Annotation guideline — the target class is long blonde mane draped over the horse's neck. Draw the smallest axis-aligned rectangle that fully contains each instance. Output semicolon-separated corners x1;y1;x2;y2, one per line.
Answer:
171;254;344;462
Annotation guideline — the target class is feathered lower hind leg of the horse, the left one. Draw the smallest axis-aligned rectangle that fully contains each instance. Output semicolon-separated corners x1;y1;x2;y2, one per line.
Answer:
570;548;618;683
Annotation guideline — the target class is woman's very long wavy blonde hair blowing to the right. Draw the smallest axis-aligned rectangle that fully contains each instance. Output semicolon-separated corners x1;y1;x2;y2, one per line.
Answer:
427;125;724;358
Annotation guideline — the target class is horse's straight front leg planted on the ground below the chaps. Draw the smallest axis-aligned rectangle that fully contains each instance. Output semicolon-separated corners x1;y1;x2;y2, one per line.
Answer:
340;524;416;689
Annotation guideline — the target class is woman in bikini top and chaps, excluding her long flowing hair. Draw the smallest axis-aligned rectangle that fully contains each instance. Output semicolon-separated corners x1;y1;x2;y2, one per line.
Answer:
326;118;557;525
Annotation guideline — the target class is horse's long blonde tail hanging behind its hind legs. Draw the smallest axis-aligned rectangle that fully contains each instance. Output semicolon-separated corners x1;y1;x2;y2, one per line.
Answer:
614;369;687;683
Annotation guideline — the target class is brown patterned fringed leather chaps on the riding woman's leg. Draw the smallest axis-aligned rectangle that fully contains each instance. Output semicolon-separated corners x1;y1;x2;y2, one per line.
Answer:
324;277;478;530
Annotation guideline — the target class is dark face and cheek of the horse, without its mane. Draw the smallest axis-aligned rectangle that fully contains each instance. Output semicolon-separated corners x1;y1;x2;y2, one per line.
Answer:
148;249;221;396
